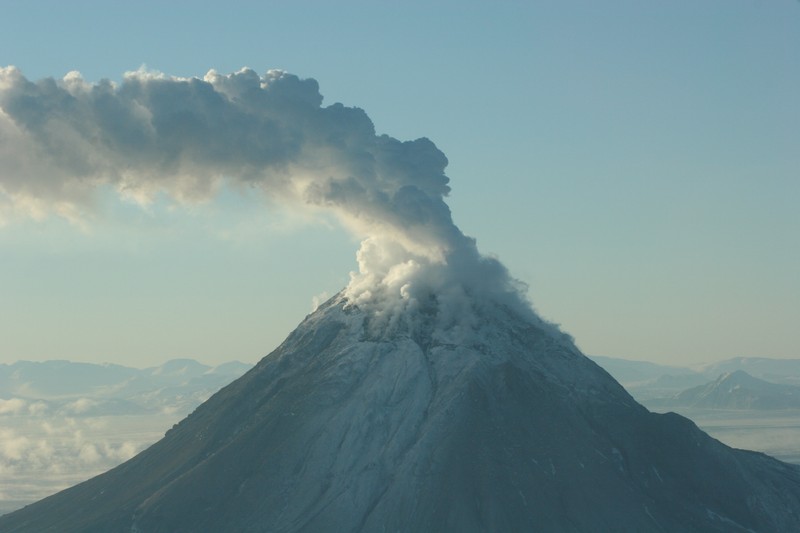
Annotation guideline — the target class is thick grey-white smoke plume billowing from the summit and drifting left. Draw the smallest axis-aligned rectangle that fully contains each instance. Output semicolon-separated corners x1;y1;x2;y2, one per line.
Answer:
0;67;533;329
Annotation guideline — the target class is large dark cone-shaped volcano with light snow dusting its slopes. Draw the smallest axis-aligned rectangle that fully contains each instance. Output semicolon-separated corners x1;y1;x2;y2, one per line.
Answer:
0;296;800;533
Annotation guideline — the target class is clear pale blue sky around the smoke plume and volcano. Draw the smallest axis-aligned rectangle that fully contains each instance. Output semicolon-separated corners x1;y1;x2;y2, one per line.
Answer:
0;0;800;367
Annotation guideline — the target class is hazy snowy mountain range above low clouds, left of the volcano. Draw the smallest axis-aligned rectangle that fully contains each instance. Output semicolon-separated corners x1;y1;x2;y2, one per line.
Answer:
0;359;252;416
